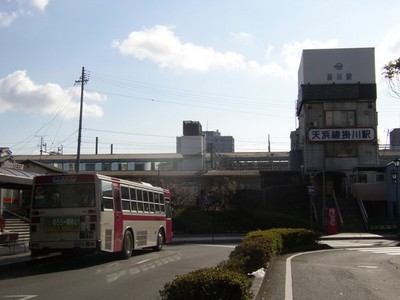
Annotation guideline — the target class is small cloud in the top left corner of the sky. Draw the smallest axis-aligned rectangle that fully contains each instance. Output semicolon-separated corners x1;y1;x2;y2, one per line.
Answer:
0;0;50;28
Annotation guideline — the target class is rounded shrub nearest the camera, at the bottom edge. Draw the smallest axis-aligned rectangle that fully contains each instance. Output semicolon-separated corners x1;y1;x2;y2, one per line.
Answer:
160;267;252;300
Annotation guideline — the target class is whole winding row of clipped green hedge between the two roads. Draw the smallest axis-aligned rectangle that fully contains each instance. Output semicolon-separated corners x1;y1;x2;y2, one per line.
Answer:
160;228;318;300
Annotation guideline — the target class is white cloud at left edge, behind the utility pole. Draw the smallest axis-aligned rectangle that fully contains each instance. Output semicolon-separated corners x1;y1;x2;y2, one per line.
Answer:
0;70;105;119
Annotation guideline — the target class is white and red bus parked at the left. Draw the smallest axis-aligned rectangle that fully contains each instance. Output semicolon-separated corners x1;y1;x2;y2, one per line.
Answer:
29;173;172;258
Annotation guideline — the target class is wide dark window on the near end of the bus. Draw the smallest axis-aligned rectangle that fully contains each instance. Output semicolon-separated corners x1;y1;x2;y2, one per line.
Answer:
32;183;95;209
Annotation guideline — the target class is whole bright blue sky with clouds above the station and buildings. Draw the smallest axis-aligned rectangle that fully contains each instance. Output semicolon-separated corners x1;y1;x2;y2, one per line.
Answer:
0;0;400;155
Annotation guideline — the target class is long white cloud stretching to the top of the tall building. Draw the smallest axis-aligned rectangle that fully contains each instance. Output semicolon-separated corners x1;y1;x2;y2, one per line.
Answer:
113;25;338;77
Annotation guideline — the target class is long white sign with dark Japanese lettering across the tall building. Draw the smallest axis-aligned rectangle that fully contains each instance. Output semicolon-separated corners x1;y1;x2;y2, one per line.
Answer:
308;128;375;142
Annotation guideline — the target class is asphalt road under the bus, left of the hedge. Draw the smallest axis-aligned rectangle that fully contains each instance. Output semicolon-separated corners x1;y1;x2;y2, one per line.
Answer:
0;244;235;300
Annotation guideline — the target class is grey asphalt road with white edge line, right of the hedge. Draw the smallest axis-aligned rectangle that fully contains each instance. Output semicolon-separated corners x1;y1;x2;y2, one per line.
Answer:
263;240;400;300
